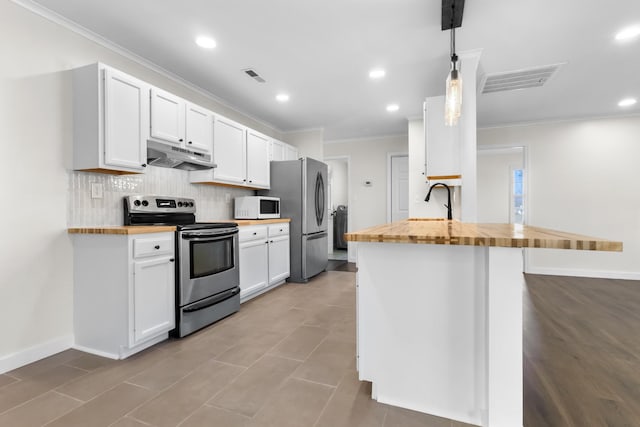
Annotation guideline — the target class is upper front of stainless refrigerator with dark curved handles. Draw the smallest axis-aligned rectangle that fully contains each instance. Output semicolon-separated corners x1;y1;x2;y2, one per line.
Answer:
302;158;328;234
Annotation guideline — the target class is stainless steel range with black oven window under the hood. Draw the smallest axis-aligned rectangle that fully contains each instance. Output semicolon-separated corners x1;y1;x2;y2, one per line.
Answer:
124;196;240;337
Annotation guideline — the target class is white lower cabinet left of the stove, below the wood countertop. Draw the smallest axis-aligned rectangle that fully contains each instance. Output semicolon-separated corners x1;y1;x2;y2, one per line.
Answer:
73;232;175;359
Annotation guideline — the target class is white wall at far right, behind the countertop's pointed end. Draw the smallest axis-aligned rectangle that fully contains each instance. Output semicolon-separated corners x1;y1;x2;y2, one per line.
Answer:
478;116;640;279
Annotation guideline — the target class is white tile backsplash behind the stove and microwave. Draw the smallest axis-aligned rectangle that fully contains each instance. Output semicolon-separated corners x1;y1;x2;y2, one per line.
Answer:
67;166;254;227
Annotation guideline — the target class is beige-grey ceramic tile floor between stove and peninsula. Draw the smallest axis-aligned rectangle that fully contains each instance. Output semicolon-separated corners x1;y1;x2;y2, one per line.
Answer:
0;271;476;427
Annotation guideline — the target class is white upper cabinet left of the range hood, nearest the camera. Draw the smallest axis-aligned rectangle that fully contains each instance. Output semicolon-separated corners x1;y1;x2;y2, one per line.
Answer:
73;63;149;174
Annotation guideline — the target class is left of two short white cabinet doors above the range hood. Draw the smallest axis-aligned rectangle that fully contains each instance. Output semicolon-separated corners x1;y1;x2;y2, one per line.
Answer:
151;88;185;147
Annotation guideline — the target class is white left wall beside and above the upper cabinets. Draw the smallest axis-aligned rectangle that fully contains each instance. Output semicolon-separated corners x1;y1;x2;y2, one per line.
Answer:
0;1;272;372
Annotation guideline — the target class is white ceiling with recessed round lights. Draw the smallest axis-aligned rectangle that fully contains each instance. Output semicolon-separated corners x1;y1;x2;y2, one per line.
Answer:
27;0;640;140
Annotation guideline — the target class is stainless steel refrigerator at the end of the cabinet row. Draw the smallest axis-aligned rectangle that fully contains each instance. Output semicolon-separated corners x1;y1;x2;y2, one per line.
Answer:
260;157;329;283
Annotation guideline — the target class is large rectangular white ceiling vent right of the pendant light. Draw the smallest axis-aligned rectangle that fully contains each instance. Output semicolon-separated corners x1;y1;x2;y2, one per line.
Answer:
481;63;565;93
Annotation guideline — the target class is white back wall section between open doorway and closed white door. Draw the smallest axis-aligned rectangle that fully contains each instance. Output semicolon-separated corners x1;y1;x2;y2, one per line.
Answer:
324;136;407;261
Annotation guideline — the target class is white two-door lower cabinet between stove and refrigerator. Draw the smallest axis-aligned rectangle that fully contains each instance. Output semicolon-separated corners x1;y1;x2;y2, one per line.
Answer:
239;223;290;302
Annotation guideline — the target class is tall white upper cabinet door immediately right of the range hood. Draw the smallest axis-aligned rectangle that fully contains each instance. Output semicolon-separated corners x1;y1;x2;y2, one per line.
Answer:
212;117;247;185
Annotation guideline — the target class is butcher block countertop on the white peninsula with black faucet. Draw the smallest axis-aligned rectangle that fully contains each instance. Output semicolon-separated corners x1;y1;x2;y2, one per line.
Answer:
345;218;622;252
